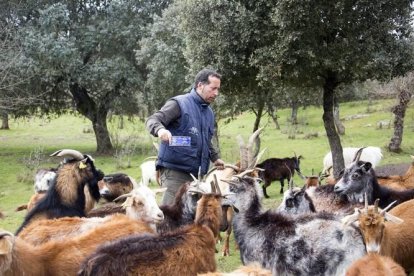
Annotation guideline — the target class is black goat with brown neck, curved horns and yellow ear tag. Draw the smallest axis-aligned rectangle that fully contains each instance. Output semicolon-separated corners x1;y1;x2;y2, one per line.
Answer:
16;149;103;235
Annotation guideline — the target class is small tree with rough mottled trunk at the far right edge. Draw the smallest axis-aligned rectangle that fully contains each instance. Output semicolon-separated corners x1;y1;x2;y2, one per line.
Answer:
388;72;414;152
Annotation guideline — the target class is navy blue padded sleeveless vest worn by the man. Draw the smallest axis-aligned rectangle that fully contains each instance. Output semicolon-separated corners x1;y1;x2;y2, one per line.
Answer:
157;89;214;177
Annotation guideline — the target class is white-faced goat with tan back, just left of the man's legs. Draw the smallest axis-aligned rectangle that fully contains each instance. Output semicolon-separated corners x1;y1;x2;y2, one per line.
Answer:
19;180;164;245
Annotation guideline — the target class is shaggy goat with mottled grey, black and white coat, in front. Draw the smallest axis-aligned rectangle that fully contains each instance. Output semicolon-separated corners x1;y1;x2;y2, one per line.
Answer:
223;177;366;275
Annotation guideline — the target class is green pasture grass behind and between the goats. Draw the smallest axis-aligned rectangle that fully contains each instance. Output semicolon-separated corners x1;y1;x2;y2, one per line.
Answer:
0;100;414;271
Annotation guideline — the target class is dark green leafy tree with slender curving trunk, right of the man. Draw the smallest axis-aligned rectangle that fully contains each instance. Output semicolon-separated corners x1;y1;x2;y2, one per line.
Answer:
258;0;413;176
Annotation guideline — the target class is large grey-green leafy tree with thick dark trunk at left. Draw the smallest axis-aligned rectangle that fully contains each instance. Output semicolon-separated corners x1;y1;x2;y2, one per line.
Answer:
4;0;168;153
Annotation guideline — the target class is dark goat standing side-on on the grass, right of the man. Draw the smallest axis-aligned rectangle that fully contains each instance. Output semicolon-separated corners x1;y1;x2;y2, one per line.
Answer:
256;154;303;198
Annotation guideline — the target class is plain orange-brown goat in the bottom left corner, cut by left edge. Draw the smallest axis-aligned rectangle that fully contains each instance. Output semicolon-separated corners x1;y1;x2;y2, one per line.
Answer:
0;216;153;276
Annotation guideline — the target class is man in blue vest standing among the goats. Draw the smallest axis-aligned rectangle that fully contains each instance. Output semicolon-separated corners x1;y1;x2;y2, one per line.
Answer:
146;69;224;204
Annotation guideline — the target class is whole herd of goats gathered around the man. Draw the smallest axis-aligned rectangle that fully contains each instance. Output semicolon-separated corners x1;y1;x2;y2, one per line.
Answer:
0;129;414;276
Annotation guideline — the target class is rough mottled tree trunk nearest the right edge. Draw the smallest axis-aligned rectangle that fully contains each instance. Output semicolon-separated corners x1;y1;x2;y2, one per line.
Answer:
388;89;411;152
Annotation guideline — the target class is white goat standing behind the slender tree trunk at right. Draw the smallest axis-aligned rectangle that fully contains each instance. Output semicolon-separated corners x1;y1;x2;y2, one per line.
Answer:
322;147;382;175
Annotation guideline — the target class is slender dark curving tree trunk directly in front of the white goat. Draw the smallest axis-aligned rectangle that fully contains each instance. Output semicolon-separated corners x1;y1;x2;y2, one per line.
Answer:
322;73;345;178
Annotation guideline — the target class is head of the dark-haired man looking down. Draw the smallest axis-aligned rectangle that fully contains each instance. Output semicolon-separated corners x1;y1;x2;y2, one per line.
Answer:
194;69;221;103
